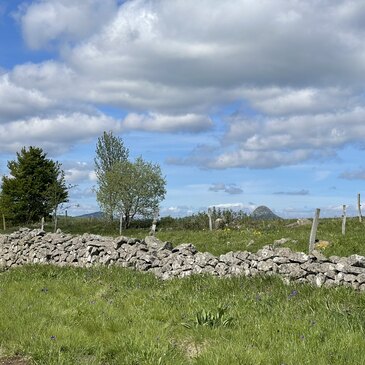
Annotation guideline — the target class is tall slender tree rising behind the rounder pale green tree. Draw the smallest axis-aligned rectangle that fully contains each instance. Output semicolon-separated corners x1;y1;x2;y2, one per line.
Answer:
94;132;129;220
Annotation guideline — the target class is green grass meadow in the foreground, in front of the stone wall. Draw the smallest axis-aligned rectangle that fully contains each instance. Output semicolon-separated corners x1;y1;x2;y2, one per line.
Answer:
0;266;365;365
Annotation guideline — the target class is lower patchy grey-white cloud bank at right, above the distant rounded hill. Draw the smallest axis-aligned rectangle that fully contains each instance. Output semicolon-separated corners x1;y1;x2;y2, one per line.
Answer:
200;106;365;168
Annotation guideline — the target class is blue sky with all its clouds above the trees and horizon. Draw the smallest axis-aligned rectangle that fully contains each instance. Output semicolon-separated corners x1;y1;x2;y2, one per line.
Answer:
0;0;365;218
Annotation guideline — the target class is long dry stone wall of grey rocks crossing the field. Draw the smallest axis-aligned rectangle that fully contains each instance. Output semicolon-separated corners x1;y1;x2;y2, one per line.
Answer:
0;228;365;291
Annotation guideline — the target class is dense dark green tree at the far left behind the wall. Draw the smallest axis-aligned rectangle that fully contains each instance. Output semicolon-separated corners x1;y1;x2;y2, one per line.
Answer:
0;147;68;223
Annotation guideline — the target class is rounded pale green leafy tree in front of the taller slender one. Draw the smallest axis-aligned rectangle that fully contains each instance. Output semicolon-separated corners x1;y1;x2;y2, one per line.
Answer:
98;157;166;228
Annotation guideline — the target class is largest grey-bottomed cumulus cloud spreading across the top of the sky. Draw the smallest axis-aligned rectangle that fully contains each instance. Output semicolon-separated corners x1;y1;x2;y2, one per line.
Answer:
13;0;365;112
